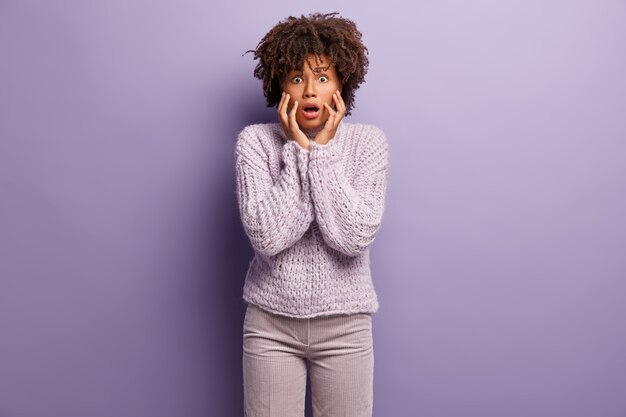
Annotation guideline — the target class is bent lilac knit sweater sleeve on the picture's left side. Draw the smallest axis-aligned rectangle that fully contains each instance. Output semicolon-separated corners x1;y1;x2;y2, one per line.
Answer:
235;127;315;256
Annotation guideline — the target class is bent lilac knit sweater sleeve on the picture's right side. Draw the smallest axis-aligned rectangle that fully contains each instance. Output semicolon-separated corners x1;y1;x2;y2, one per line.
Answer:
309;128;389;256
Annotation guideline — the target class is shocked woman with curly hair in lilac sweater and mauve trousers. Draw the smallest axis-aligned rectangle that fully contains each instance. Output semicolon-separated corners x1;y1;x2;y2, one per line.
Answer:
235;13;388;417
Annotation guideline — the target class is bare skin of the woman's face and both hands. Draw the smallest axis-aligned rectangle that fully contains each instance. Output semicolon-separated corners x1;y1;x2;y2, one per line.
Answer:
277;55;346;149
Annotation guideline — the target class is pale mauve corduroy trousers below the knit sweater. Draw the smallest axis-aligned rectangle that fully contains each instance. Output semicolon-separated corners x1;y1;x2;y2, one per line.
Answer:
243;304;374;417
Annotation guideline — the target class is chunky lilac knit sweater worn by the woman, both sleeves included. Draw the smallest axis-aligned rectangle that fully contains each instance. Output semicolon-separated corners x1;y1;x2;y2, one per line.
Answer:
235;121;388;318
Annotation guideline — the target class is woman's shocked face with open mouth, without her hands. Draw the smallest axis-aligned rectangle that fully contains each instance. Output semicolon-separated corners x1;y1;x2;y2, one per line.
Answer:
281;54;341;129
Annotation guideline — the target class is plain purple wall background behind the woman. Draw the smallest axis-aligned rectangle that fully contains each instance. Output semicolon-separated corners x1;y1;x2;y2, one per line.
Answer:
0;0;626;417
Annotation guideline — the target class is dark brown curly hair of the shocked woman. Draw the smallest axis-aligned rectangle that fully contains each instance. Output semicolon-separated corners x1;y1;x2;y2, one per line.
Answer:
244;12;369;115
